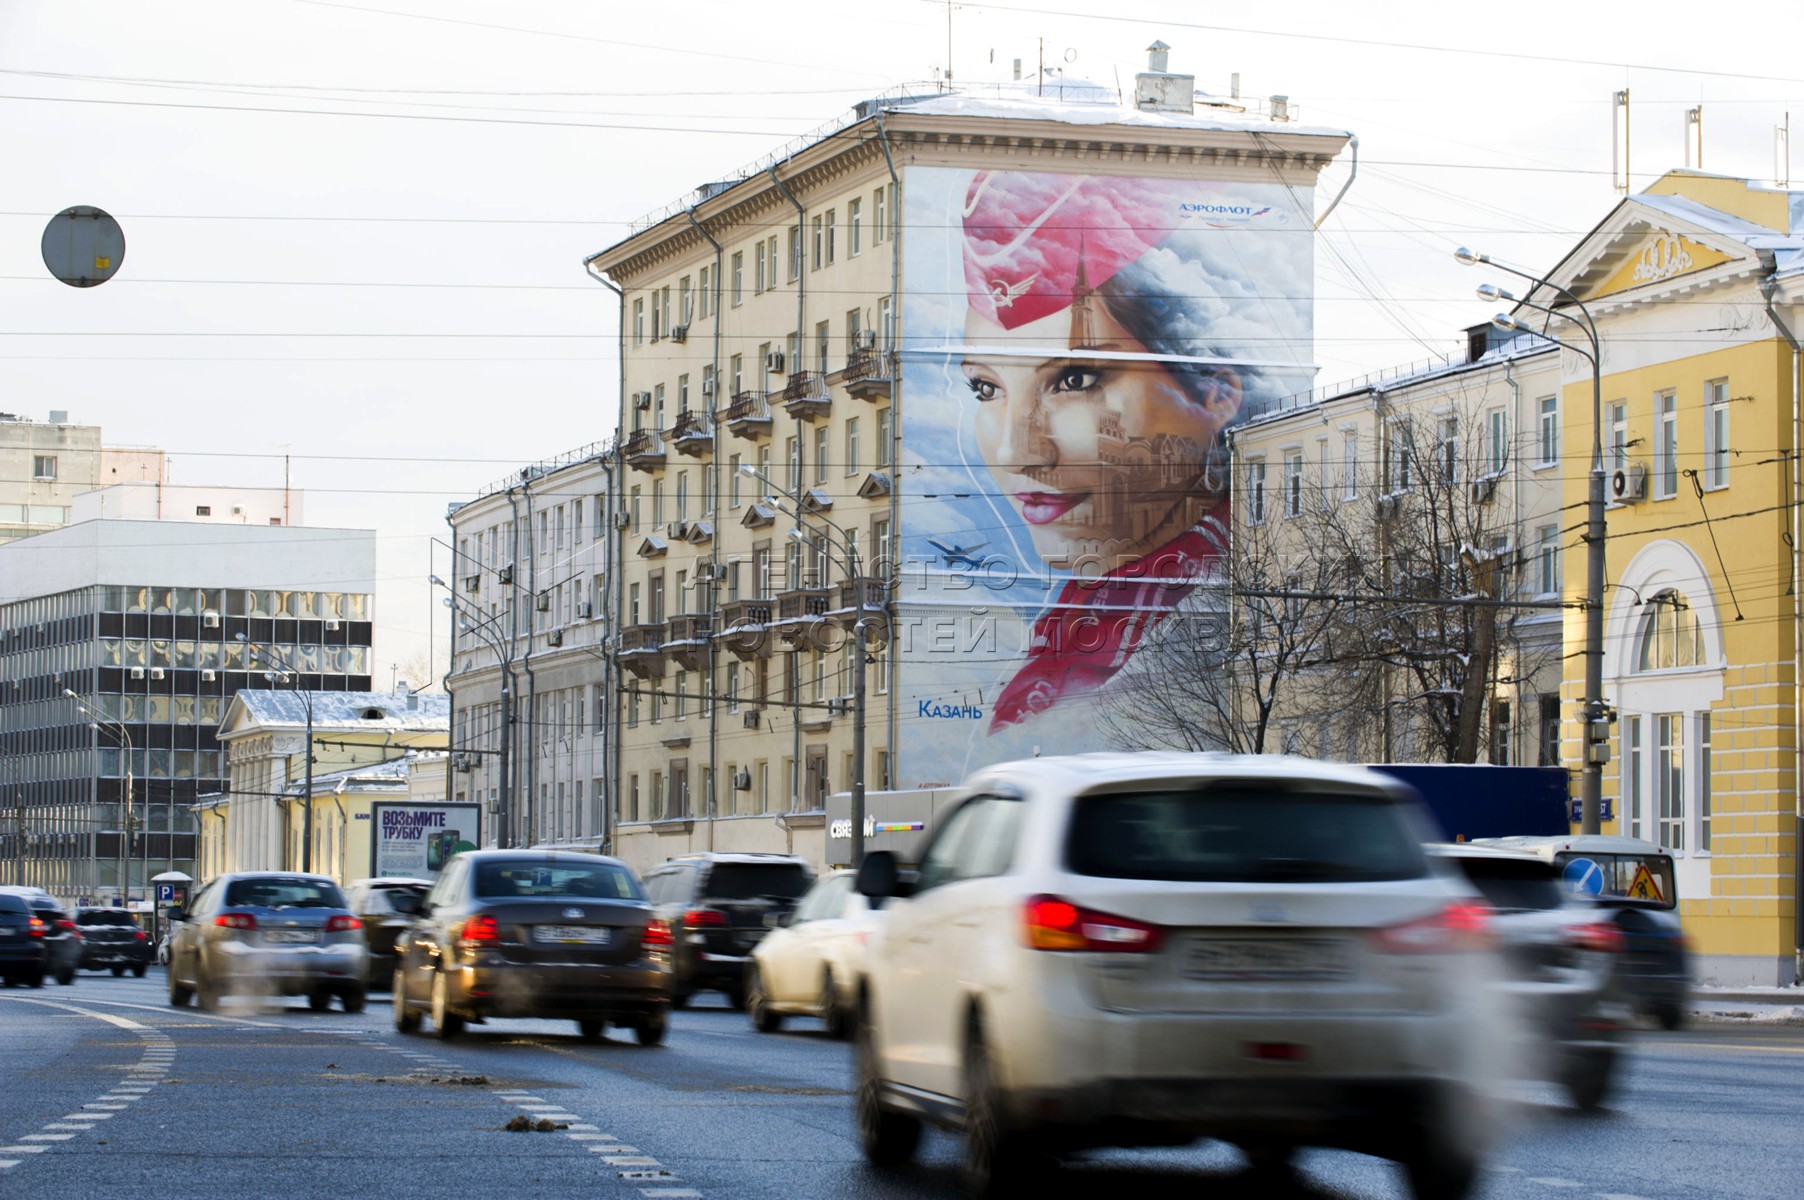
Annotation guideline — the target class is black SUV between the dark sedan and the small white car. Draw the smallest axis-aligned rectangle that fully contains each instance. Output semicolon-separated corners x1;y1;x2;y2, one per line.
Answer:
646;854;814;1009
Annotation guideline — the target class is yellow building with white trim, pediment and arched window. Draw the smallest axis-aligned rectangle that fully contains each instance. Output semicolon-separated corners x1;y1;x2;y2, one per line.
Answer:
1522;171;1804;983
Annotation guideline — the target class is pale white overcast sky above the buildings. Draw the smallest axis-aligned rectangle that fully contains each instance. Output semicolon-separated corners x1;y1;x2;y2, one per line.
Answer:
0;0;1804;688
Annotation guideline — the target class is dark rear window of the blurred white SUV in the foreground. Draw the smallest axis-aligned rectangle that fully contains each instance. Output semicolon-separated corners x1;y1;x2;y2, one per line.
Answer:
1066;785;1429;884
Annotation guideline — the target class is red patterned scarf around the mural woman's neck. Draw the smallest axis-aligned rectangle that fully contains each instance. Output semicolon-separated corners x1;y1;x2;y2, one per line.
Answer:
990;516;1227;733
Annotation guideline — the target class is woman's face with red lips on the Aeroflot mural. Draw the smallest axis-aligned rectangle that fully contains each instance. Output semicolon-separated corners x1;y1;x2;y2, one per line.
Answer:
963;298;1241;574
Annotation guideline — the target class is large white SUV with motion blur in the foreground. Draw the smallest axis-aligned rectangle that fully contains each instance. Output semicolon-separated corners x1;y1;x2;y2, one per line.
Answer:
857;754;1496;1198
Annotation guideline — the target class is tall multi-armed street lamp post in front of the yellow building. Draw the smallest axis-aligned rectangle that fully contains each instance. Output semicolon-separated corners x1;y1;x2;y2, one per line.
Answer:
1454;247;1609;834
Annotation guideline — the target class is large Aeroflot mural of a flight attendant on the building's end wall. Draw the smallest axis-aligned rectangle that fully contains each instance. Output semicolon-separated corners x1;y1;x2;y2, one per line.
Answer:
895;168;1313;787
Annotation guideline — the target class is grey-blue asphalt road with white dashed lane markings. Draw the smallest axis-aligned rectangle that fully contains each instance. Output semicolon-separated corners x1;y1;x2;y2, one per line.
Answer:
0;969;1804;1200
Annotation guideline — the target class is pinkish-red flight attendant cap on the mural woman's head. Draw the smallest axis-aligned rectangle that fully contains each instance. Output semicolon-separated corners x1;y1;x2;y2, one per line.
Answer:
965;171;1185;328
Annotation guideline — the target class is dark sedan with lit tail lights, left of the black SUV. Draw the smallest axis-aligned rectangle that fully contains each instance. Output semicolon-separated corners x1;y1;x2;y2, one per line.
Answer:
393;850;671;1047
